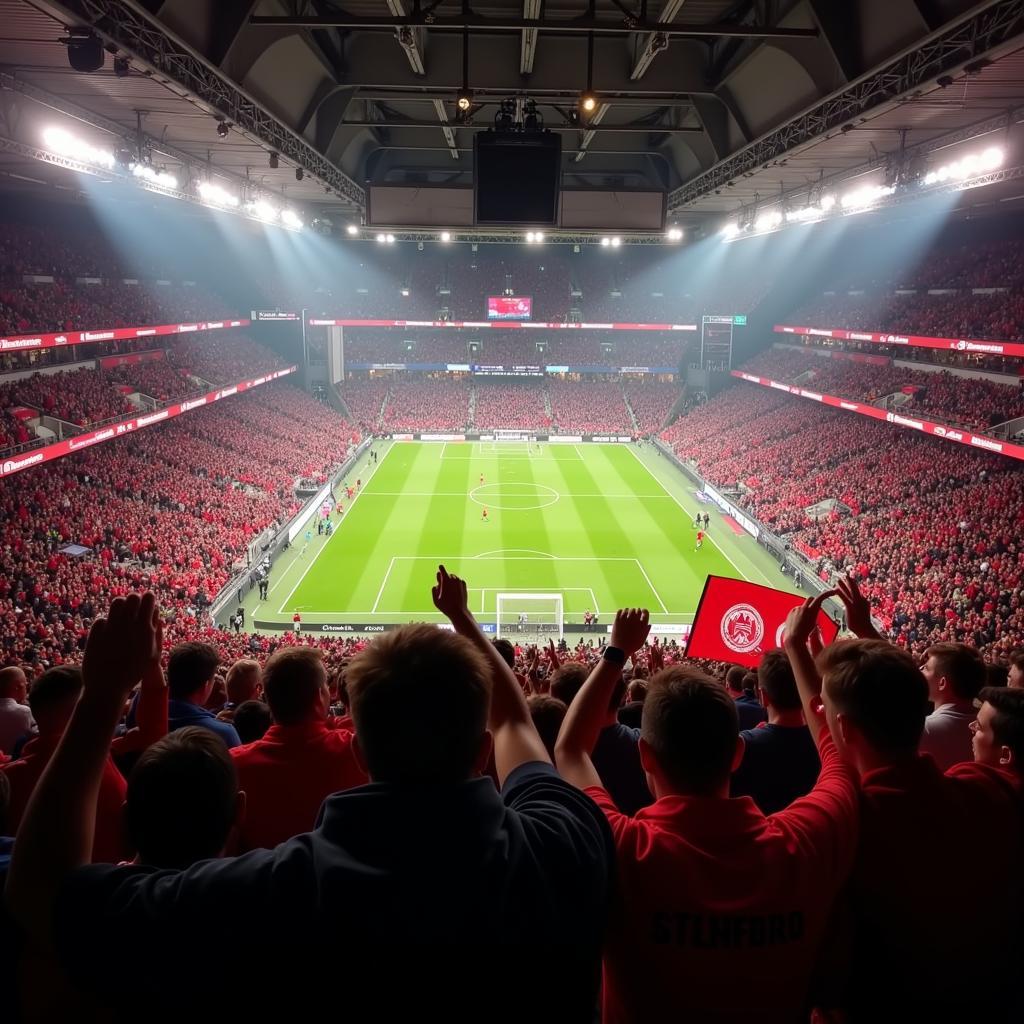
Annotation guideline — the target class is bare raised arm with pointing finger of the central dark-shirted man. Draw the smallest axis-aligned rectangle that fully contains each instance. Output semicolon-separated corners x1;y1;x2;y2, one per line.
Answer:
431;565;551;784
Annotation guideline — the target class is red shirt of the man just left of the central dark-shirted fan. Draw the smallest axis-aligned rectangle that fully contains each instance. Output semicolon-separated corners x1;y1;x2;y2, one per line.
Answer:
230;721;368;851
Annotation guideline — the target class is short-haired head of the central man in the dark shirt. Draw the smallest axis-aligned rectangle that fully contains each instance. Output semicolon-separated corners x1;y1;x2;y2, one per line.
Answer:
346;623;492;785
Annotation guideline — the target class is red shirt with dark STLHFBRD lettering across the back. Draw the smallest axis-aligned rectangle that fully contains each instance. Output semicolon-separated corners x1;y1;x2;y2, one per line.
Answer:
587;729;858;1024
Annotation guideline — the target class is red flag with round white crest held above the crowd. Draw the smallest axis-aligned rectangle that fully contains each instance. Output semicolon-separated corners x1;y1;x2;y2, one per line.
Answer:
686;575;839;669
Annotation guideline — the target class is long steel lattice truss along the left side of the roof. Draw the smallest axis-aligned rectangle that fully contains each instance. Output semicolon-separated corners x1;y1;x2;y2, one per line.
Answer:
43;0;366;208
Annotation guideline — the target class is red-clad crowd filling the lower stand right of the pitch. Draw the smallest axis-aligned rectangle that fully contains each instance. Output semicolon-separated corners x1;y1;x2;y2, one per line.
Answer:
663;376;1024;653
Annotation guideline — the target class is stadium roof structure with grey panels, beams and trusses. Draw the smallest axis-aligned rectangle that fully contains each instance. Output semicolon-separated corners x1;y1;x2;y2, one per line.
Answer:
0;0;1024;227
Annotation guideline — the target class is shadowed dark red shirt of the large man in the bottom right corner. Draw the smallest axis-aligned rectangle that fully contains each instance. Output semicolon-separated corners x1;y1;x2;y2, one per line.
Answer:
849;755;1024;1020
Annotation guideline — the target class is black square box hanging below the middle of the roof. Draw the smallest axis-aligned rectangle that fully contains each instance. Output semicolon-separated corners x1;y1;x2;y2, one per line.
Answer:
473;131;562;227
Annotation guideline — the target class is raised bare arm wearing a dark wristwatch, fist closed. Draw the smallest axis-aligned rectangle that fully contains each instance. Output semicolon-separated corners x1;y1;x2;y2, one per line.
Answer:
555;608;650;790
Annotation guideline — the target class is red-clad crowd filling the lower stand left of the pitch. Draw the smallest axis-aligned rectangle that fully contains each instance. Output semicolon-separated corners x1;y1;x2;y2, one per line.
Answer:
0;382;351;668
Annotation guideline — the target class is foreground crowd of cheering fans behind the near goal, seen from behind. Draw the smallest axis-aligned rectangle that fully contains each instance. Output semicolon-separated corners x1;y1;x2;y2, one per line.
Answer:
0;566;1024;1024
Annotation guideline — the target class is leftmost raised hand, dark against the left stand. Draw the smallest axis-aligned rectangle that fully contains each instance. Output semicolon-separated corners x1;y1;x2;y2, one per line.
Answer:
82;593;163;701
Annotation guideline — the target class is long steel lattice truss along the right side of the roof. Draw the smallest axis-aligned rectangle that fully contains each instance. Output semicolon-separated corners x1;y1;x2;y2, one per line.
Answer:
668;0;1024;211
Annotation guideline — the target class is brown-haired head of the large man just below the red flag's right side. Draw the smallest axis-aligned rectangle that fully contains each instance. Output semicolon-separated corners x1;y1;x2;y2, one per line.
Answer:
818;640;928;756
